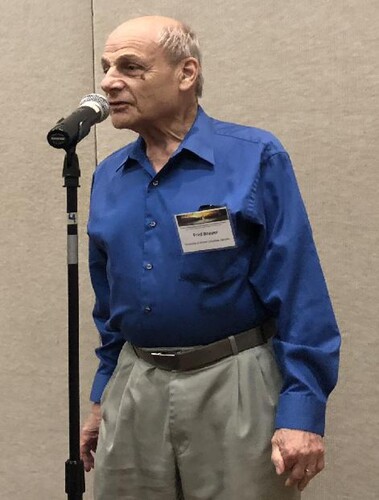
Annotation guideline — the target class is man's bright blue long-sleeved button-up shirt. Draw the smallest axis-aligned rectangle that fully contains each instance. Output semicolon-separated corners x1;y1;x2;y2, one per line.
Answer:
88;108;340;434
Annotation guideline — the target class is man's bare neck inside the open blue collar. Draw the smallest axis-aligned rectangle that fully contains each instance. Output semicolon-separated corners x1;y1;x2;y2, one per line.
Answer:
140;103;198;172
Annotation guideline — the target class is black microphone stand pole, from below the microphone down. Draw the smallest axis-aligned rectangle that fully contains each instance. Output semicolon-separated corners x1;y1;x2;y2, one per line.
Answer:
63;145;85;500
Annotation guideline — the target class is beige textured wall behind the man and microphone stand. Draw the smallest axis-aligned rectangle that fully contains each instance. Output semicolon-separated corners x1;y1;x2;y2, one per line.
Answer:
0;0;379;500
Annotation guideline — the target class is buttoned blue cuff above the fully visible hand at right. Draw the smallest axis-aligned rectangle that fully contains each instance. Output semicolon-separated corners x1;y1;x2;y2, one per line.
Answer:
275;393;326;436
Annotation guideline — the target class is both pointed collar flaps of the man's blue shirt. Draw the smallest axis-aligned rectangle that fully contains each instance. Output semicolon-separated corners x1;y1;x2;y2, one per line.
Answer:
117;106;215;170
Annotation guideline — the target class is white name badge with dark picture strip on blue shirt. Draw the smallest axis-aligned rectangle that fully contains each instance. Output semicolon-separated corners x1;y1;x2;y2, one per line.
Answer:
175;207;236;253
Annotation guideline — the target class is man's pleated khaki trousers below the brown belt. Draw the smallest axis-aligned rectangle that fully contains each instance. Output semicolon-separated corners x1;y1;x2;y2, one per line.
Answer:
94;344;300;500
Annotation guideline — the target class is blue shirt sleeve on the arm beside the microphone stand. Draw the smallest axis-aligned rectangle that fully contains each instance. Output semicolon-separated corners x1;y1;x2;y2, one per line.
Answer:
89;232;125;403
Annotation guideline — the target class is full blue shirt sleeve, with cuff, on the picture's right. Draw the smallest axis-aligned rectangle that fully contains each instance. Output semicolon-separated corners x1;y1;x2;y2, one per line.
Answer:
250;152;340;435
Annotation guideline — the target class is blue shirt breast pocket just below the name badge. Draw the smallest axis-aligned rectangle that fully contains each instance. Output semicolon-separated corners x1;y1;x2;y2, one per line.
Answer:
180;248;240;284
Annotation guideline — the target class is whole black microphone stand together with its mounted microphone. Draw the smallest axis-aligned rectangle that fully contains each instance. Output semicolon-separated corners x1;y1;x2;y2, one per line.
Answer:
47;94;109;500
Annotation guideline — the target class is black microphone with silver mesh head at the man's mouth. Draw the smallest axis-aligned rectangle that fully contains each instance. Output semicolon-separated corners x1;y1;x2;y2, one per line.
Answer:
47;94;109;150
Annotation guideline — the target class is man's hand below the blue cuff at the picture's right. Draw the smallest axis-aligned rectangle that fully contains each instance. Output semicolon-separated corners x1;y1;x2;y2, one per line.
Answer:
271;429;325;491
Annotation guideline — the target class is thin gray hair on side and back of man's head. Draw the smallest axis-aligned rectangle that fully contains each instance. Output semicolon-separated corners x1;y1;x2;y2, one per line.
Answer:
158;24;204;97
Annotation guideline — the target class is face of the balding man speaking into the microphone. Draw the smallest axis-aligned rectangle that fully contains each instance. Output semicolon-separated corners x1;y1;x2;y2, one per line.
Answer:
101;24;183;132
